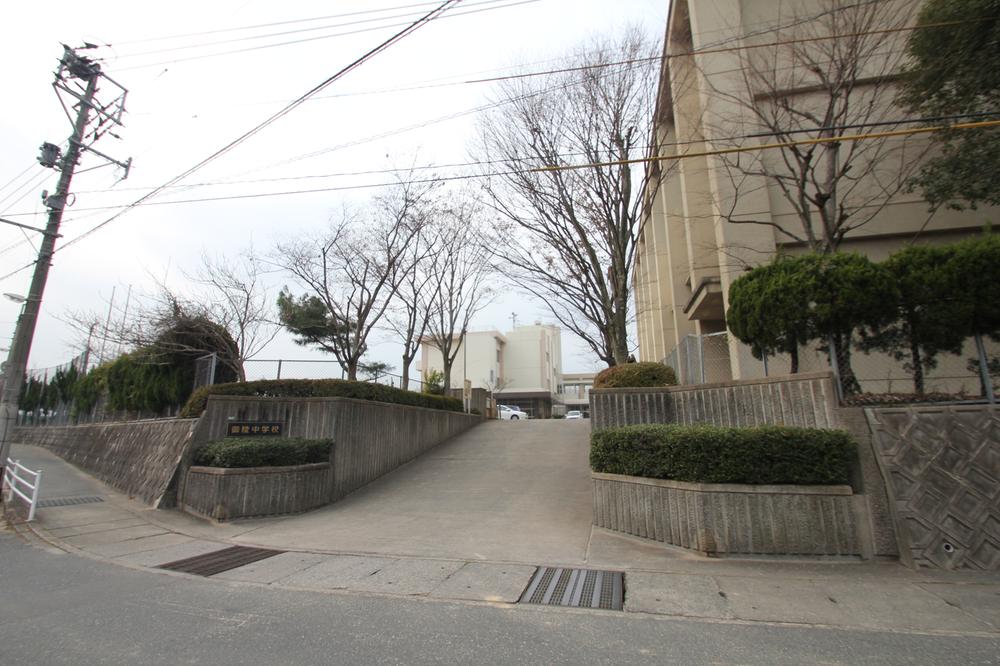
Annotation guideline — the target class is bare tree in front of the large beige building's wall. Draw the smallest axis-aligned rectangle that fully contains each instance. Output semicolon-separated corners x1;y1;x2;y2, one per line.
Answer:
701;0;927;253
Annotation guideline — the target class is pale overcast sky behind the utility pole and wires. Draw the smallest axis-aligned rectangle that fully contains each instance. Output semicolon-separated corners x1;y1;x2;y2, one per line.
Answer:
0;0;668;376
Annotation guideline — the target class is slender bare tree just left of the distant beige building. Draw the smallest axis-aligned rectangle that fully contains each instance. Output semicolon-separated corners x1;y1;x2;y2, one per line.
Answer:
424;193;495;390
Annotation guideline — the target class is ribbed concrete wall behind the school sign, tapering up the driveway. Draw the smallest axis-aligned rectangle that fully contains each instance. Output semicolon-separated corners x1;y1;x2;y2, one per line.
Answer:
199;396;482;501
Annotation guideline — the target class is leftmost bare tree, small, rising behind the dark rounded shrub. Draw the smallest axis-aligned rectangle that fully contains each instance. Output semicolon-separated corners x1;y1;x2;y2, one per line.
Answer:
192;246;280;382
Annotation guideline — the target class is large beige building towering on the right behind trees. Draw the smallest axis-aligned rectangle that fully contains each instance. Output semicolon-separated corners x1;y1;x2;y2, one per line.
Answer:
633;0;995;390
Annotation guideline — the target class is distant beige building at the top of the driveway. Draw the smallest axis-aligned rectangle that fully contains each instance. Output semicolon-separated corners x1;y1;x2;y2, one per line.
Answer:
420;322;562;418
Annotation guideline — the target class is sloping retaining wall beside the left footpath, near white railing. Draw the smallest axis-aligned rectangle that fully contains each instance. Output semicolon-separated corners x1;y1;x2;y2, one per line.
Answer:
13;419;197;506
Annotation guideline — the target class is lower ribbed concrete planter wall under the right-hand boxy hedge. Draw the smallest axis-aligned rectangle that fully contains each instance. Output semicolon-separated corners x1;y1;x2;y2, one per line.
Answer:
592;472;870;557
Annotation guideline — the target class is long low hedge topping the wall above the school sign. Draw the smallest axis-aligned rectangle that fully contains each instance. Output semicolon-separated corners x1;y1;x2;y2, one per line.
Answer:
180;379;463;418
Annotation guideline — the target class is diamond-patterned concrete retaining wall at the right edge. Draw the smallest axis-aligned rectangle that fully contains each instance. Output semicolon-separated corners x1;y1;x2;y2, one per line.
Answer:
865;405;1000;571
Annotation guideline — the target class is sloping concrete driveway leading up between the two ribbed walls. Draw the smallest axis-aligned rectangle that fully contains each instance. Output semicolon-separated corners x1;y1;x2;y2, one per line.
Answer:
229;420;592;563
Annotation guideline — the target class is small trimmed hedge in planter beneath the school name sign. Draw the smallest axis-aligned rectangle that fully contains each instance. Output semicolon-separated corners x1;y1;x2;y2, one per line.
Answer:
194;437;333;467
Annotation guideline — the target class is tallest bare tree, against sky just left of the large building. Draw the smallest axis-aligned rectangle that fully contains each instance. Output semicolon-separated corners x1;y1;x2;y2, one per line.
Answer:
481;29;662;366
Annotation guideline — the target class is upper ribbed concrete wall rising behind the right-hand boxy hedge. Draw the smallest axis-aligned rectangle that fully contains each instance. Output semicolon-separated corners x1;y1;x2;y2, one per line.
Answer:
590;372;837;430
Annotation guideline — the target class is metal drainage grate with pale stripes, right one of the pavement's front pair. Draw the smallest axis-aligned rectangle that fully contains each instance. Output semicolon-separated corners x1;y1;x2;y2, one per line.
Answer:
519;567;624;610
